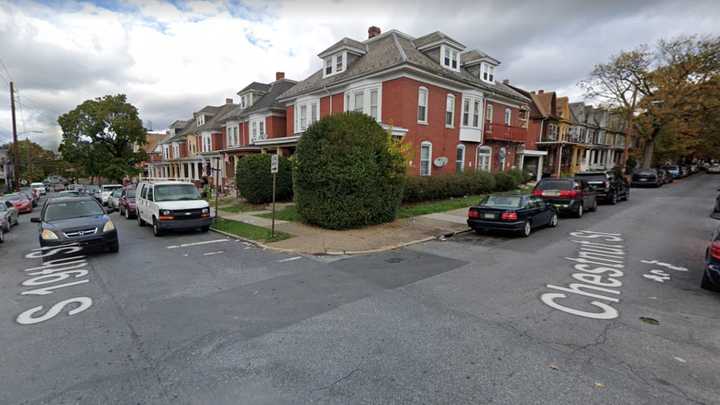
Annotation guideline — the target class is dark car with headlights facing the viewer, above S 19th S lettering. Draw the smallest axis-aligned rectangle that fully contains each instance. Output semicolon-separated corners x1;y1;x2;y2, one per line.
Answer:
31;197;119;252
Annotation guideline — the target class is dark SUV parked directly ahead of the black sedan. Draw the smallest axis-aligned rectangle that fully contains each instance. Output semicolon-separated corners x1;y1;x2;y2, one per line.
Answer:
532;177;597;218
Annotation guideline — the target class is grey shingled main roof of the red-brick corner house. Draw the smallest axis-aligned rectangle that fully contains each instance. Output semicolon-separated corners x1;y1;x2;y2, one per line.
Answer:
280;31;529;102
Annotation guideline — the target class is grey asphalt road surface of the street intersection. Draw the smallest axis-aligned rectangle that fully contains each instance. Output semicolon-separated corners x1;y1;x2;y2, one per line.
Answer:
0;175;720;404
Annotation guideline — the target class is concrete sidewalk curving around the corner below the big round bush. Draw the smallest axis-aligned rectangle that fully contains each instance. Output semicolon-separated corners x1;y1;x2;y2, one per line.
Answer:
221;208;468;255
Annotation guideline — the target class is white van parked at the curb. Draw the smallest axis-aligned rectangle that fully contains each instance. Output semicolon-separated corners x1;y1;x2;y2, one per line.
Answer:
135;181;212;236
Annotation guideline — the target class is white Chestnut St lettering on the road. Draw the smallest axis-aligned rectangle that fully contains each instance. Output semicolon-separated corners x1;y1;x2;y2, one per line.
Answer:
540;231;625;319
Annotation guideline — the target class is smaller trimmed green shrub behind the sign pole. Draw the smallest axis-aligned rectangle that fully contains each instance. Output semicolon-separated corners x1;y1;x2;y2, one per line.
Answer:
235;154;293;204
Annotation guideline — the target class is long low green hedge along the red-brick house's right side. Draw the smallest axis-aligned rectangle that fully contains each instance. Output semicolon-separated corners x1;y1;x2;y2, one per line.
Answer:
403;172;495;203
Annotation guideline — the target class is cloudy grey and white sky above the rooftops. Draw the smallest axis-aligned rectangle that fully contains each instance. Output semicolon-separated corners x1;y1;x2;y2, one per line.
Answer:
0;0;720;147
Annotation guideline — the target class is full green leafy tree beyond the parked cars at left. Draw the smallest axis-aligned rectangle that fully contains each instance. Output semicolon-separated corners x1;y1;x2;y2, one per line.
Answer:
58;94;146;180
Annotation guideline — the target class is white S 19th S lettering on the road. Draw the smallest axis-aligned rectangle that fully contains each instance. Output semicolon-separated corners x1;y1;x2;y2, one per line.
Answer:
15;244;93;325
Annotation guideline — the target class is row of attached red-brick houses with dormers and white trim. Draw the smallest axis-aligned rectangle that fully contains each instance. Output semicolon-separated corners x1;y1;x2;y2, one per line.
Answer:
146;27;632;186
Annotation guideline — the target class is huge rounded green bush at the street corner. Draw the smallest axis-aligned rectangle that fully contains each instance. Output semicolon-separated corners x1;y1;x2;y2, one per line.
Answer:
293;113;405;229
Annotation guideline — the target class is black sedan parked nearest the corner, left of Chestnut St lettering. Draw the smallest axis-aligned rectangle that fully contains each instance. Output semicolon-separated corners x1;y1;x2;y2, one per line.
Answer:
467;194;558;236
